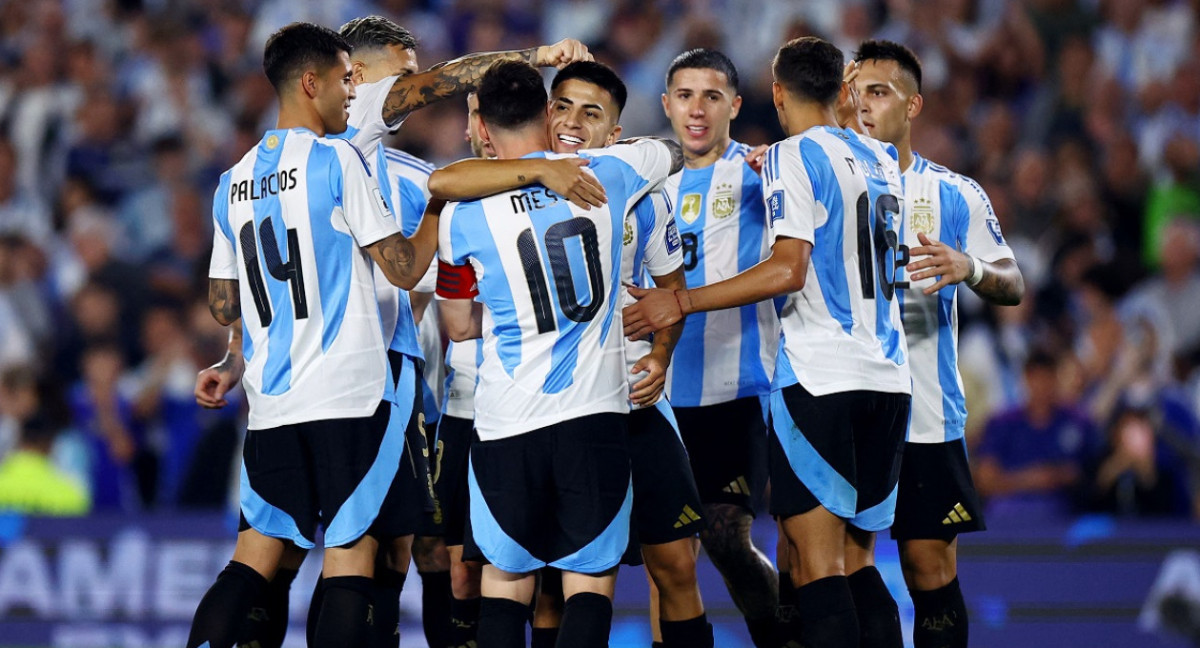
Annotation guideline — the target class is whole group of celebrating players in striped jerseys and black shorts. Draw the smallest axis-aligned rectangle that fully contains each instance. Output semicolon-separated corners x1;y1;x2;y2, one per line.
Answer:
188;12;1024;648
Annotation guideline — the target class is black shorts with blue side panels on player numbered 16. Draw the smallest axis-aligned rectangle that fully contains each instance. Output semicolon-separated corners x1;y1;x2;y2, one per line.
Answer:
769;384;911;532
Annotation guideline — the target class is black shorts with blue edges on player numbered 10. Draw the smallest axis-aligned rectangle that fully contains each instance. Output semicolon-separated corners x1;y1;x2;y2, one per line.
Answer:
463;414;634;574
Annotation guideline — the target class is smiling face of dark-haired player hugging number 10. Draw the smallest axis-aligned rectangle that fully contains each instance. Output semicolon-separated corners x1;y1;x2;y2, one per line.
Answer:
547;79;620;154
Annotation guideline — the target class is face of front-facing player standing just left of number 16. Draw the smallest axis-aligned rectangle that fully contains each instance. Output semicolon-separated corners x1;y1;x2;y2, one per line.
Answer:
662;67;742;160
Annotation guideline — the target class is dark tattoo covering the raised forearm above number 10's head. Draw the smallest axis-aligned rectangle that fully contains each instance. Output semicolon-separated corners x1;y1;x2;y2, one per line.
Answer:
383;47;538;124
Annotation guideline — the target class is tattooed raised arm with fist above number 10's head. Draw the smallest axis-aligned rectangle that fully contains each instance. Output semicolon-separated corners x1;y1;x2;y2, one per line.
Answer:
383;38;592;124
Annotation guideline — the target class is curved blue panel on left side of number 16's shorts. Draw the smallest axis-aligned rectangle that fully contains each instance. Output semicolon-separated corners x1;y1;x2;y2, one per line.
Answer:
770;390;858;518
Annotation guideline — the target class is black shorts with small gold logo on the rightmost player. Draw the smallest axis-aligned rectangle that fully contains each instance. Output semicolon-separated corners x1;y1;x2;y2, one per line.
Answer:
892;439;988;541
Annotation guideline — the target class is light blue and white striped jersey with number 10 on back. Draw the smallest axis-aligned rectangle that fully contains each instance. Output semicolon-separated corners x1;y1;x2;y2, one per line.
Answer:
438;140;671;440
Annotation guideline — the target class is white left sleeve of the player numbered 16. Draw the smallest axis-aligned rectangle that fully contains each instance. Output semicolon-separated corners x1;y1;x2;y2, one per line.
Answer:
762;139;818;245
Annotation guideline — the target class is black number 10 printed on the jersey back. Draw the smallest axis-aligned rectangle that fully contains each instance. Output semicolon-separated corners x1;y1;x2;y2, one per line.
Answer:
517;216;604;334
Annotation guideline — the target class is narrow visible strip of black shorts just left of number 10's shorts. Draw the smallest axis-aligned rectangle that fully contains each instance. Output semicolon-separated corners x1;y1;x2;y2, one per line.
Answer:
433;416;475;546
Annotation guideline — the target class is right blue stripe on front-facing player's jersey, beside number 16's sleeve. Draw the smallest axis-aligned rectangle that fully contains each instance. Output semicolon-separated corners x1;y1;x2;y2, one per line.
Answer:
738;159;770;398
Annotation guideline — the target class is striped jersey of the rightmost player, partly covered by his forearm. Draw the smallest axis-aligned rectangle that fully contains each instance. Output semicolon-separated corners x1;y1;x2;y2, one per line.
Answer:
900;154;1014;443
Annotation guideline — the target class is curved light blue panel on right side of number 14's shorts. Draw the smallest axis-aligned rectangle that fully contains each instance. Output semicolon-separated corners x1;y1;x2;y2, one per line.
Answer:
325;358;418;547
